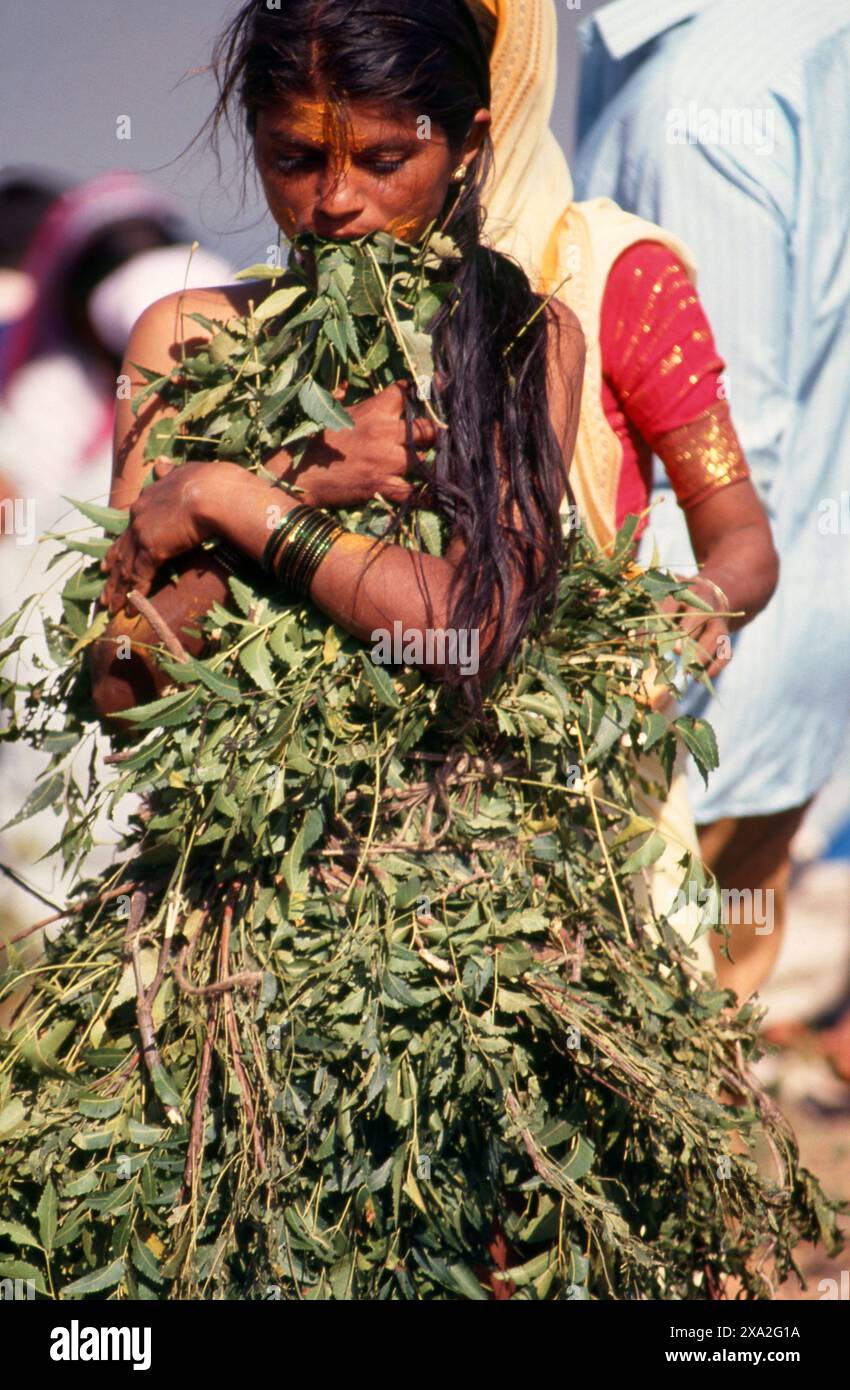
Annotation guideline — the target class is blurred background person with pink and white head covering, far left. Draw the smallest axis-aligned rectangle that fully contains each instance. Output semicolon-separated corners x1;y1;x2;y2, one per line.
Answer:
0;174;231;572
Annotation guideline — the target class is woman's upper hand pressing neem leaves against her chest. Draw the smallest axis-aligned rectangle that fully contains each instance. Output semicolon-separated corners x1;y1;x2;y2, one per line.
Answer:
286;381;438;507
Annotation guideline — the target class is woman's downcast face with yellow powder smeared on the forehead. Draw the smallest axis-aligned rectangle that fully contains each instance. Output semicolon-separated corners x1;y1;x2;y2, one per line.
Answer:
254;99;490;240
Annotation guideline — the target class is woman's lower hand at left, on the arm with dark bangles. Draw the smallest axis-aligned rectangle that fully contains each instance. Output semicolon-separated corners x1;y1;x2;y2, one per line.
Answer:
100;459;242;616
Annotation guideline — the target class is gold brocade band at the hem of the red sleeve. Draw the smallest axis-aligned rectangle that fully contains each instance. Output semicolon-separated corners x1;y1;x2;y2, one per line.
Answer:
656;400;750;512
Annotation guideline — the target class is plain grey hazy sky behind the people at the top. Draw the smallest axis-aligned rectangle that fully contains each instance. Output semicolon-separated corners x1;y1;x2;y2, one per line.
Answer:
0;0;601;267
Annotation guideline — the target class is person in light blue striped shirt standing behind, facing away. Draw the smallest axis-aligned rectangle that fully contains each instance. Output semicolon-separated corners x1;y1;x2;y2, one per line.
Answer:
575;0;850;998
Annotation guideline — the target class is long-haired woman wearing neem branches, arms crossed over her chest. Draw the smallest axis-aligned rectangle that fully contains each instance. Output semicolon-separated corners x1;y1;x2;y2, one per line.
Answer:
0;0;832;1300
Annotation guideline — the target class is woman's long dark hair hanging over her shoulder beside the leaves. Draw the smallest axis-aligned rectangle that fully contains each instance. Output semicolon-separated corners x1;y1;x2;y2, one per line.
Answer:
206;0;576;689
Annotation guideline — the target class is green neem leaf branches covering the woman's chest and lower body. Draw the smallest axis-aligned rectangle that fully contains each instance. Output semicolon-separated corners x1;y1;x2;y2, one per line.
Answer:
0;222;835;1300
